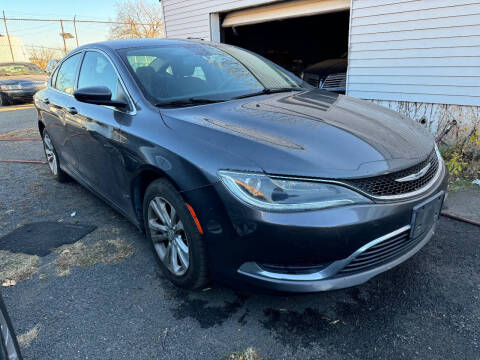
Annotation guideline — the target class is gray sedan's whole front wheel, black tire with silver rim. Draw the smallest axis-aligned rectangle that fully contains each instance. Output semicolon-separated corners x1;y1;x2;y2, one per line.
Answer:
143;179;208;290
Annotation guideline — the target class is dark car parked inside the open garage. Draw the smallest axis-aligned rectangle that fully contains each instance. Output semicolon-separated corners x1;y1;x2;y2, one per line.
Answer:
302;54;348;94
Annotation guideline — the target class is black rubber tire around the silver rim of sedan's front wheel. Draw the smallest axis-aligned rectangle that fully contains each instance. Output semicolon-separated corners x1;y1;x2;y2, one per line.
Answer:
143;179;207;289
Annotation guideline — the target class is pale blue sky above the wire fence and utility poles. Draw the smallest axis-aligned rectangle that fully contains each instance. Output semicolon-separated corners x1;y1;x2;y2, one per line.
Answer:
0;0;160;56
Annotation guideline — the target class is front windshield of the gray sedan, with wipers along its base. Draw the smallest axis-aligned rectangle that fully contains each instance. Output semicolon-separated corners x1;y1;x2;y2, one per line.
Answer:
120;44;310;105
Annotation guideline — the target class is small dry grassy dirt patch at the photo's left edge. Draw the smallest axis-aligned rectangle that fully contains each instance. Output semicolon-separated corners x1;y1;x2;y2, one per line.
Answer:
0;250;40;286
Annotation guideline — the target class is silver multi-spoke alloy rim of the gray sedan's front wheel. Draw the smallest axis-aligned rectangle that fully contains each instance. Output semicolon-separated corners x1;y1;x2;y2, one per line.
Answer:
148;196;190;276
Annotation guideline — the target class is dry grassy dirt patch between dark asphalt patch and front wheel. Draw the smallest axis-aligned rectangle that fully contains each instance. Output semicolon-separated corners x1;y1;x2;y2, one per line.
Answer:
55;239;133;276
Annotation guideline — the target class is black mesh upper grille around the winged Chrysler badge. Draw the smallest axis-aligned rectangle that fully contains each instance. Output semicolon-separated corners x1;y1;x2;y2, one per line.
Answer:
344;150;438;196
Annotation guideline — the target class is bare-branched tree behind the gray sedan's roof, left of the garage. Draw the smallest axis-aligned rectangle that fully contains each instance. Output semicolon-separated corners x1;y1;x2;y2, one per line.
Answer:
110;0;164;39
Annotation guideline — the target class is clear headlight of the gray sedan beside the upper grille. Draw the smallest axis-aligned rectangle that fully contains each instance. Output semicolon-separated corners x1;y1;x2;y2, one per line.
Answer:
218;170;371;211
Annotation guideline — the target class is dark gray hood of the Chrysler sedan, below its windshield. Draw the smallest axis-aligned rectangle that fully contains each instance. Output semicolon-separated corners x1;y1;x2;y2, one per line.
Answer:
162;89;433;178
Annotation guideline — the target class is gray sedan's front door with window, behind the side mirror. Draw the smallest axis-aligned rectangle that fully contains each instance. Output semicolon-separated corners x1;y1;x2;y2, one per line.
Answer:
67;50;133;207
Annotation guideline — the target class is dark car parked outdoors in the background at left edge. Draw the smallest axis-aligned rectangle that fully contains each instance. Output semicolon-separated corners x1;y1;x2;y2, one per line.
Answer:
0;62;48;106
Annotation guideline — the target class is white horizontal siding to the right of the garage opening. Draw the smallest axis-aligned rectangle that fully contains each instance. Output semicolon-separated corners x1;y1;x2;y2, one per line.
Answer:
347;0;480;106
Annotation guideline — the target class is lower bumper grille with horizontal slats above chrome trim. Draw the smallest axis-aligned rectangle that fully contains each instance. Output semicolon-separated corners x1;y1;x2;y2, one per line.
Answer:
335;230;422;277
